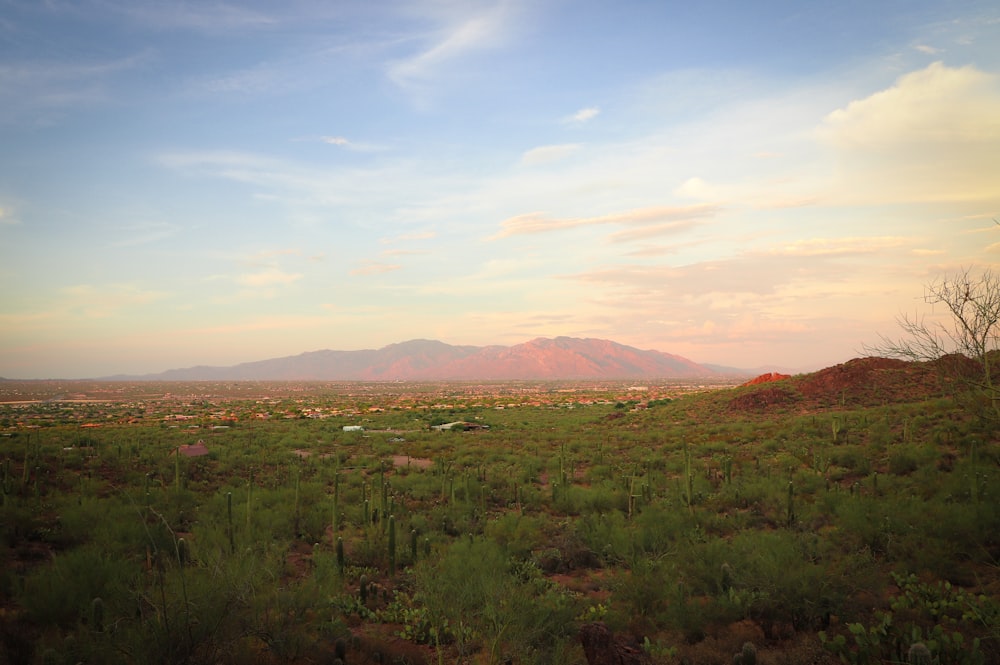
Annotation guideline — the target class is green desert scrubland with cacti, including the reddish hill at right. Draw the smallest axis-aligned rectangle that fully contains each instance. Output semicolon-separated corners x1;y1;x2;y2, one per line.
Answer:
0;366;1000;665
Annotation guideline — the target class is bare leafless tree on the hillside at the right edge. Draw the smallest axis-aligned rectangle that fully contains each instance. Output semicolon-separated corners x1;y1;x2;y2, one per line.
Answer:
865;268;1000;424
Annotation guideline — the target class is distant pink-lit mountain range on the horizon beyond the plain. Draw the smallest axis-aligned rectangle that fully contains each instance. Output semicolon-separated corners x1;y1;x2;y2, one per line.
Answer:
115;337;737;381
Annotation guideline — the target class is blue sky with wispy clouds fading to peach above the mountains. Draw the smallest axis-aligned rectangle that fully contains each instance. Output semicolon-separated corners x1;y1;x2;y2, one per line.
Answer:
0;0;1000;378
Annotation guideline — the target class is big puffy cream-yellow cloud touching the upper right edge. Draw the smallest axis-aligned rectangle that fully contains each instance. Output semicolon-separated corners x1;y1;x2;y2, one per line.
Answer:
819;62;1000;203
